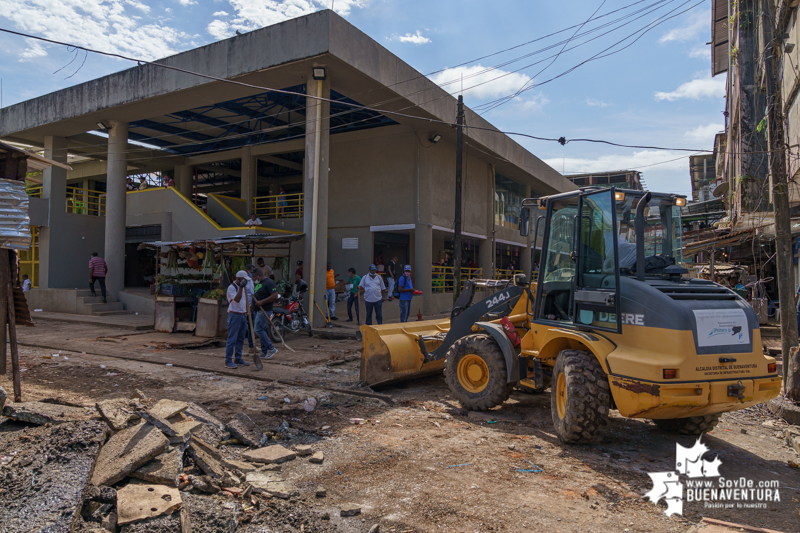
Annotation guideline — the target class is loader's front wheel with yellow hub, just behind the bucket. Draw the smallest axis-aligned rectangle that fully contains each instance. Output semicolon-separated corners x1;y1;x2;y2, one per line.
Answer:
445;335;513;411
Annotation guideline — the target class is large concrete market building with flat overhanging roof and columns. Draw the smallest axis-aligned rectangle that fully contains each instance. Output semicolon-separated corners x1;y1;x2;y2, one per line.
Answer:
0;10;575;322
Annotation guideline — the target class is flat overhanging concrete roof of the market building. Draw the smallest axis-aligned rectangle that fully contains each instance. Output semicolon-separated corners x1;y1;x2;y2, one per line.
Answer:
0;10;575;194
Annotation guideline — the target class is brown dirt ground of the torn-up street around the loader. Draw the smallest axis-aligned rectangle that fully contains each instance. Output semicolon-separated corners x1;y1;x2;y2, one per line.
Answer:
0;321;800;533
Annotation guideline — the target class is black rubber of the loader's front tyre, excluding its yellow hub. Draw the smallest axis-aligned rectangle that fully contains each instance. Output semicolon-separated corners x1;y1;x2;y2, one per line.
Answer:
445;334;514;411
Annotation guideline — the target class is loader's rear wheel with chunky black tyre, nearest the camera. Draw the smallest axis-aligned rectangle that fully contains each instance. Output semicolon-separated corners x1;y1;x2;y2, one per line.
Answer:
550;350;611;444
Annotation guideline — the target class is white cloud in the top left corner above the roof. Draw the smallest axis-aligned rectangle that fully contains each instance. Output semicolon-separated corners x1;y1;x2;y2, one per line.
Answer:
0;0;186;60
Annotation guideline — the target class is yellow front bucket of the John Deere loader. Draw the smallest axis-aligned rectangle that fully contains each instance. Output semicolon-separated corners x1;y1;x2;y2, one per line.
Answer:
361;319;450;386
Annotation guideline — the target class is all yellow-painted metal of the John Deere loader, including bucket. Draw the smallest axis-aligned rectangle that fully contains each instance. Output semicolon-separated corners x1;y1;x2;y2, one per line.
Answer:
361;278;781;419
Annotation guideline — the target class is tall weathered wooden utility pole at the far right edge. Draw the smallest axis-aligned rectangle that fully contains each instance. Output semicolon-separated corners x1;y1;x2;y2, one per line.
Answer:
761;0;800;401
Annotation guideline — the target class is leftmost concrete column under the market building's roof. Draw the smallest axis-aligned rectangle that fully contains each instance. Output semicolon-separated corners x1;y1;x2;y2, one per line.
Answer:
39;135;68;289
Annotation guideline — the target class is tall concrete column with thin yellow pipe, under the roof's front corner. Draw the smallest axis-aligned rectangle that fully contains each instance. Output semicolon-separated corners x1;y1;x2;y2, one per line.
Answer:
303;72;332;327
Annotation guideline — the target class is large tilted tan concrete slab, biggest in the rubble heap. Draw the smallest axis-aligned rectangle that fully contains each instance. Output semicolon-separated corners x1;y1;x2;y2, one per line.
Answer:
92;422;169;485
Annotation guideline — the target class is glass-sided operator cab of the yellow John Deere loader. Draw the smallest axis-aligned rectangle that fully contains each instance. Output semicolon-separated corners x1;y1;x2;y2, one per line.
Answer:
520;188;685;333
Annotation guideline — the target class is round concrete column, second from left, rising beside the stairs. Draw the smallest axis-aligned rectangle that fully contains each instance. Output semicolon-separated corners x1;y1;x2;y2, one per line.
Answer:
104;120;128;301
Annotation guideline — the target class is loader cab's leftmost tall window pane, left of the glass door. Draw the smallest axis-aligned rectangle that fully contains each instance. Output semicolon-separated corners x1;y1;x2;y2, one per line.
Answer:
538;196;579;322
